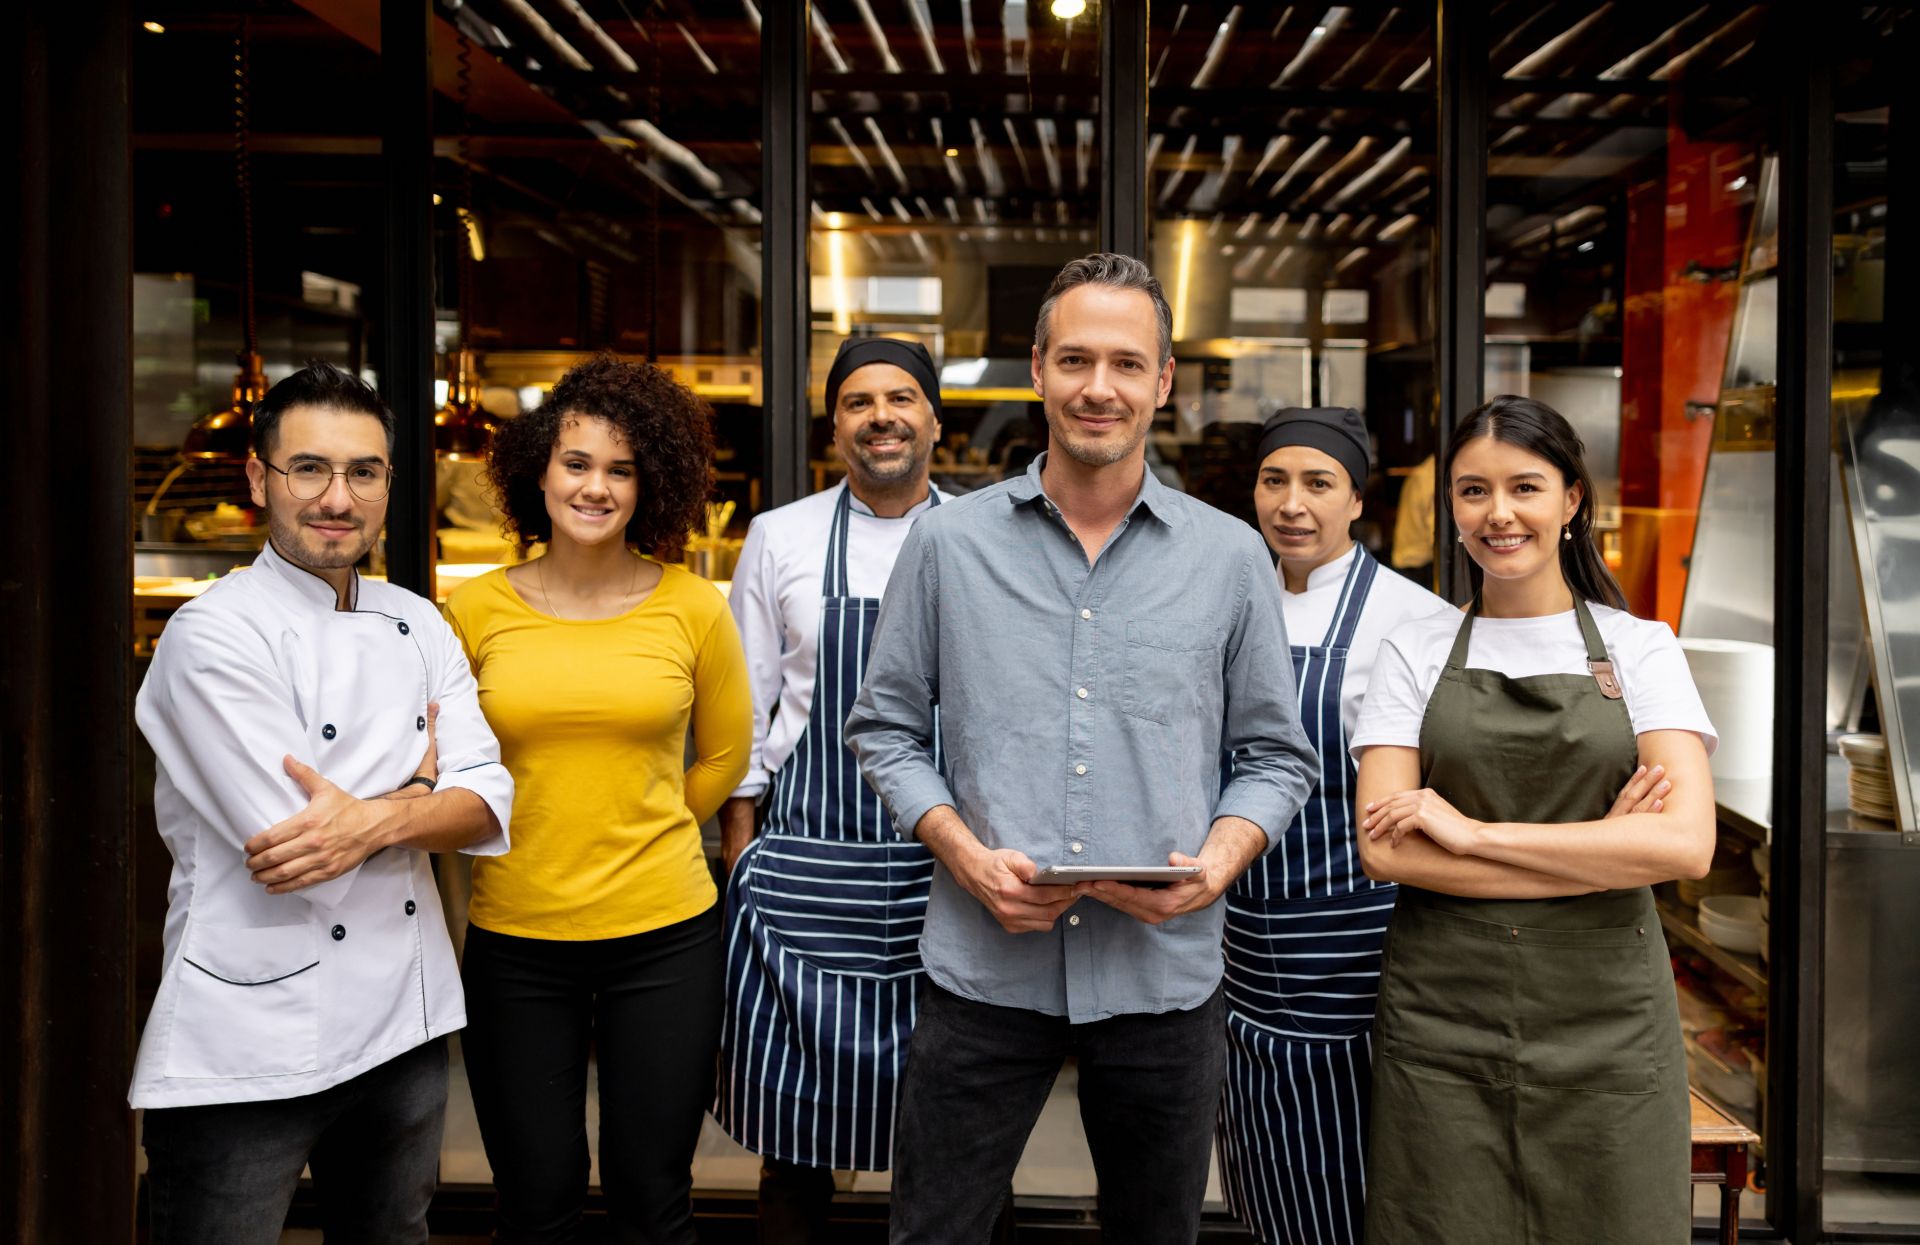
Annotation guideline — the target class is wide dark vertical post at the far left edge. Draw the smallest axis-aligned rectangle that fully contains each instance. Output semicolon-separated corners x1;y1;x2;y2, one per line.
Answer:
0;0;134;1241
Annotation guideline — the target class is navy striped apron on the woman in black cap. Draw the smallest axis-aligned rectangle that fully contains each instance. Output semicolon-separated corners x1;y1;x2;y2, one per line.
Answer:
1219;548;1396;1245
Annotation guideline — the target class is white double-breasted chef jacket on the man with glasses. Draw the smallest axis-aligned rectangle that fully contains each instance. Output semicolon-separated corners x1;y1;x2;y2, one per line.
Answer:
129;546;513;1107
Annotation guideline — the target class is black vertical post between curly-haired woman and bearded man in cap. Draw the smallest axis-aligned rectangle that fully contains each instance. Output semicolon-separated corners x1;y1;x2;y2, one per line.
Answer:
760;0;812;507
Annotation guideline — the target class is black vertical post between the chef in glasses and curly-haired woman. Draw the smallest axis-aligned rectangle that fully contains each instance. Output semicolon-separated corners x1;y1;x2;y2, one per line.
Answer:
380;0;434;596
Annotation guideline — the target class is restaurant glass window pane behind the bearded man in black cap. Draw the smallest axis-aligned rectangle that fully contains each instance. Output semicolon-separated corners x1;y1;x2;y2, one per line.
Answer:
808;0;1102;492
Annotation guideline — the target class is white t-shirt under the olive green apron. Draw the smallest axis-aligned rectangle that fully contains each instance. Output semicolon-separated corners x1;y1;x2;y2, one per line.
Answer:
1348;605;1720;757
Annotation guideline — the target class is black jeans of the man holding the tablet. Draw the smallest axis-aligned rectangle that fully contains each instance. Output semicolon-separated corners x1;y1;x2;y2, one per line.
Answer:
891;982;1227;1245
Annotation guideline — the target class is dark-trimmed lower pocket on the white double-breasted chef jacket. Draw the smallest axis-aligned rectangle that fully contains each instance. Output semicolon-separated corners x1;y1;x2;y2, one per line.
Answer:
167;920;321;1078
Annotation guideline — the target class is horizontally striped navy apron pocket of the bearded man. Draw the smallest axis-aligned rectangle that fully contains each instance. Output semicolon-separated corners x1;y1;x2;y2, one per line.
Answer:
743;834;933;976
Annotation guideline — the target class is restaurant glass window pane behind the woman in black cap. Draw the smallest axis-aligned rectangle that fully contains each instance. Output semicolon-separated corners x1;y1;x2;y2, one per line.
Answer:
1146;6;1436;574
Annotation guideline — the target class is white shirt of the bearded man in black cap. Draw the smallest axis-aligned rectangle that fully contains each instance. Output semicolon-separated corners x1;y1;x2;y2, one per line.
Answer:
728;480;948;799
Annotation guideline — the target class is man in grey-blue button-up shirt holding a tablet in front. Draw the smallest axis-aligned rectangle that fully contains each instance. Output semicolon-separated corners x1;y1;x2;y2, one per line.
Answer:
847;256;1319;1245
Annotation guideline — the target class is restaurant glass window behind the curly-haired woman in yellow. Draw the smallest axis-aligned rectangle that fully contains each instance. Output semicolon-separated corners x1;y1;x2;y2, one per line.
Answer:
420;0;766;1189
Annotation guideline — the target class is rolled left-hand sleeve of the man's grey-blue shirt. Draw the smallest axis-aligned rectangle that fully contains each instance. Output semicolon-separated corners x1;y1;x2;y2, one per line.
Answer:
847;525;954;838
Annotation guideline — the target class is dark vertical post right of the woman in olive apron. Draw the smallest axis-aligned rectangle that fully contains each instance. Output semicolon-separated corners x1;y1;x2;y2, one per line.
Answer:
1766;6;1834;1245
